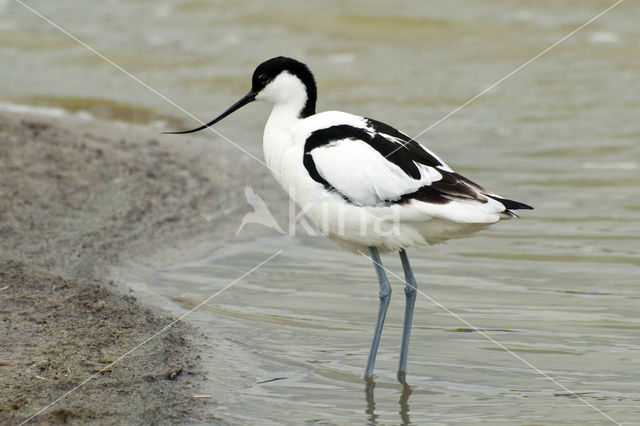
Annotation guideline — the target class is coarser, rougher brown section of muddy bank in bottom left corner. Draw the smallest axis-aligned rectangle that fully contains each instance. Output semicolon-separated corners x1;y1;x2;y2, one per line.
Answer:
0;261;206;424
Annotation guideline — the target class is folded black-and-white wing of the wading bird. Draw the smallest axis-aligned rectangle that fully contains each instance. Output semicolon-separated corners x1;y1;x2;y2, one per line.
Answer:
304;113;530;212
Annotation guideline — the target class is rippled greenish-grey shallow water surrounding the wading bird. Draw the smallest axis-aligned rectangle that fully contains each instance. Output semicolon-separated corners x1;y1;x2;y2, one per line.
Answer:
0;0;640;424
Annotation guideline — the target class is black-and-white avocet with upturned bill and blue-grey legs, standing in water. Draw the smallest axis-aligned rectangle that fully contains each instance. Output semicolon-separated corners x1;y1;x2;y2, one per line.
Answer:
165;56;533;380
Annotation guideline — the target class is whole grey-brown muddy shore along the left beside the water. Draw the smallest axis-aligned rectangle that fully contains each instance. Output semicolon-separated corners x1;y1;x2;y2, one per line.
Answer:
0;112;270;424
